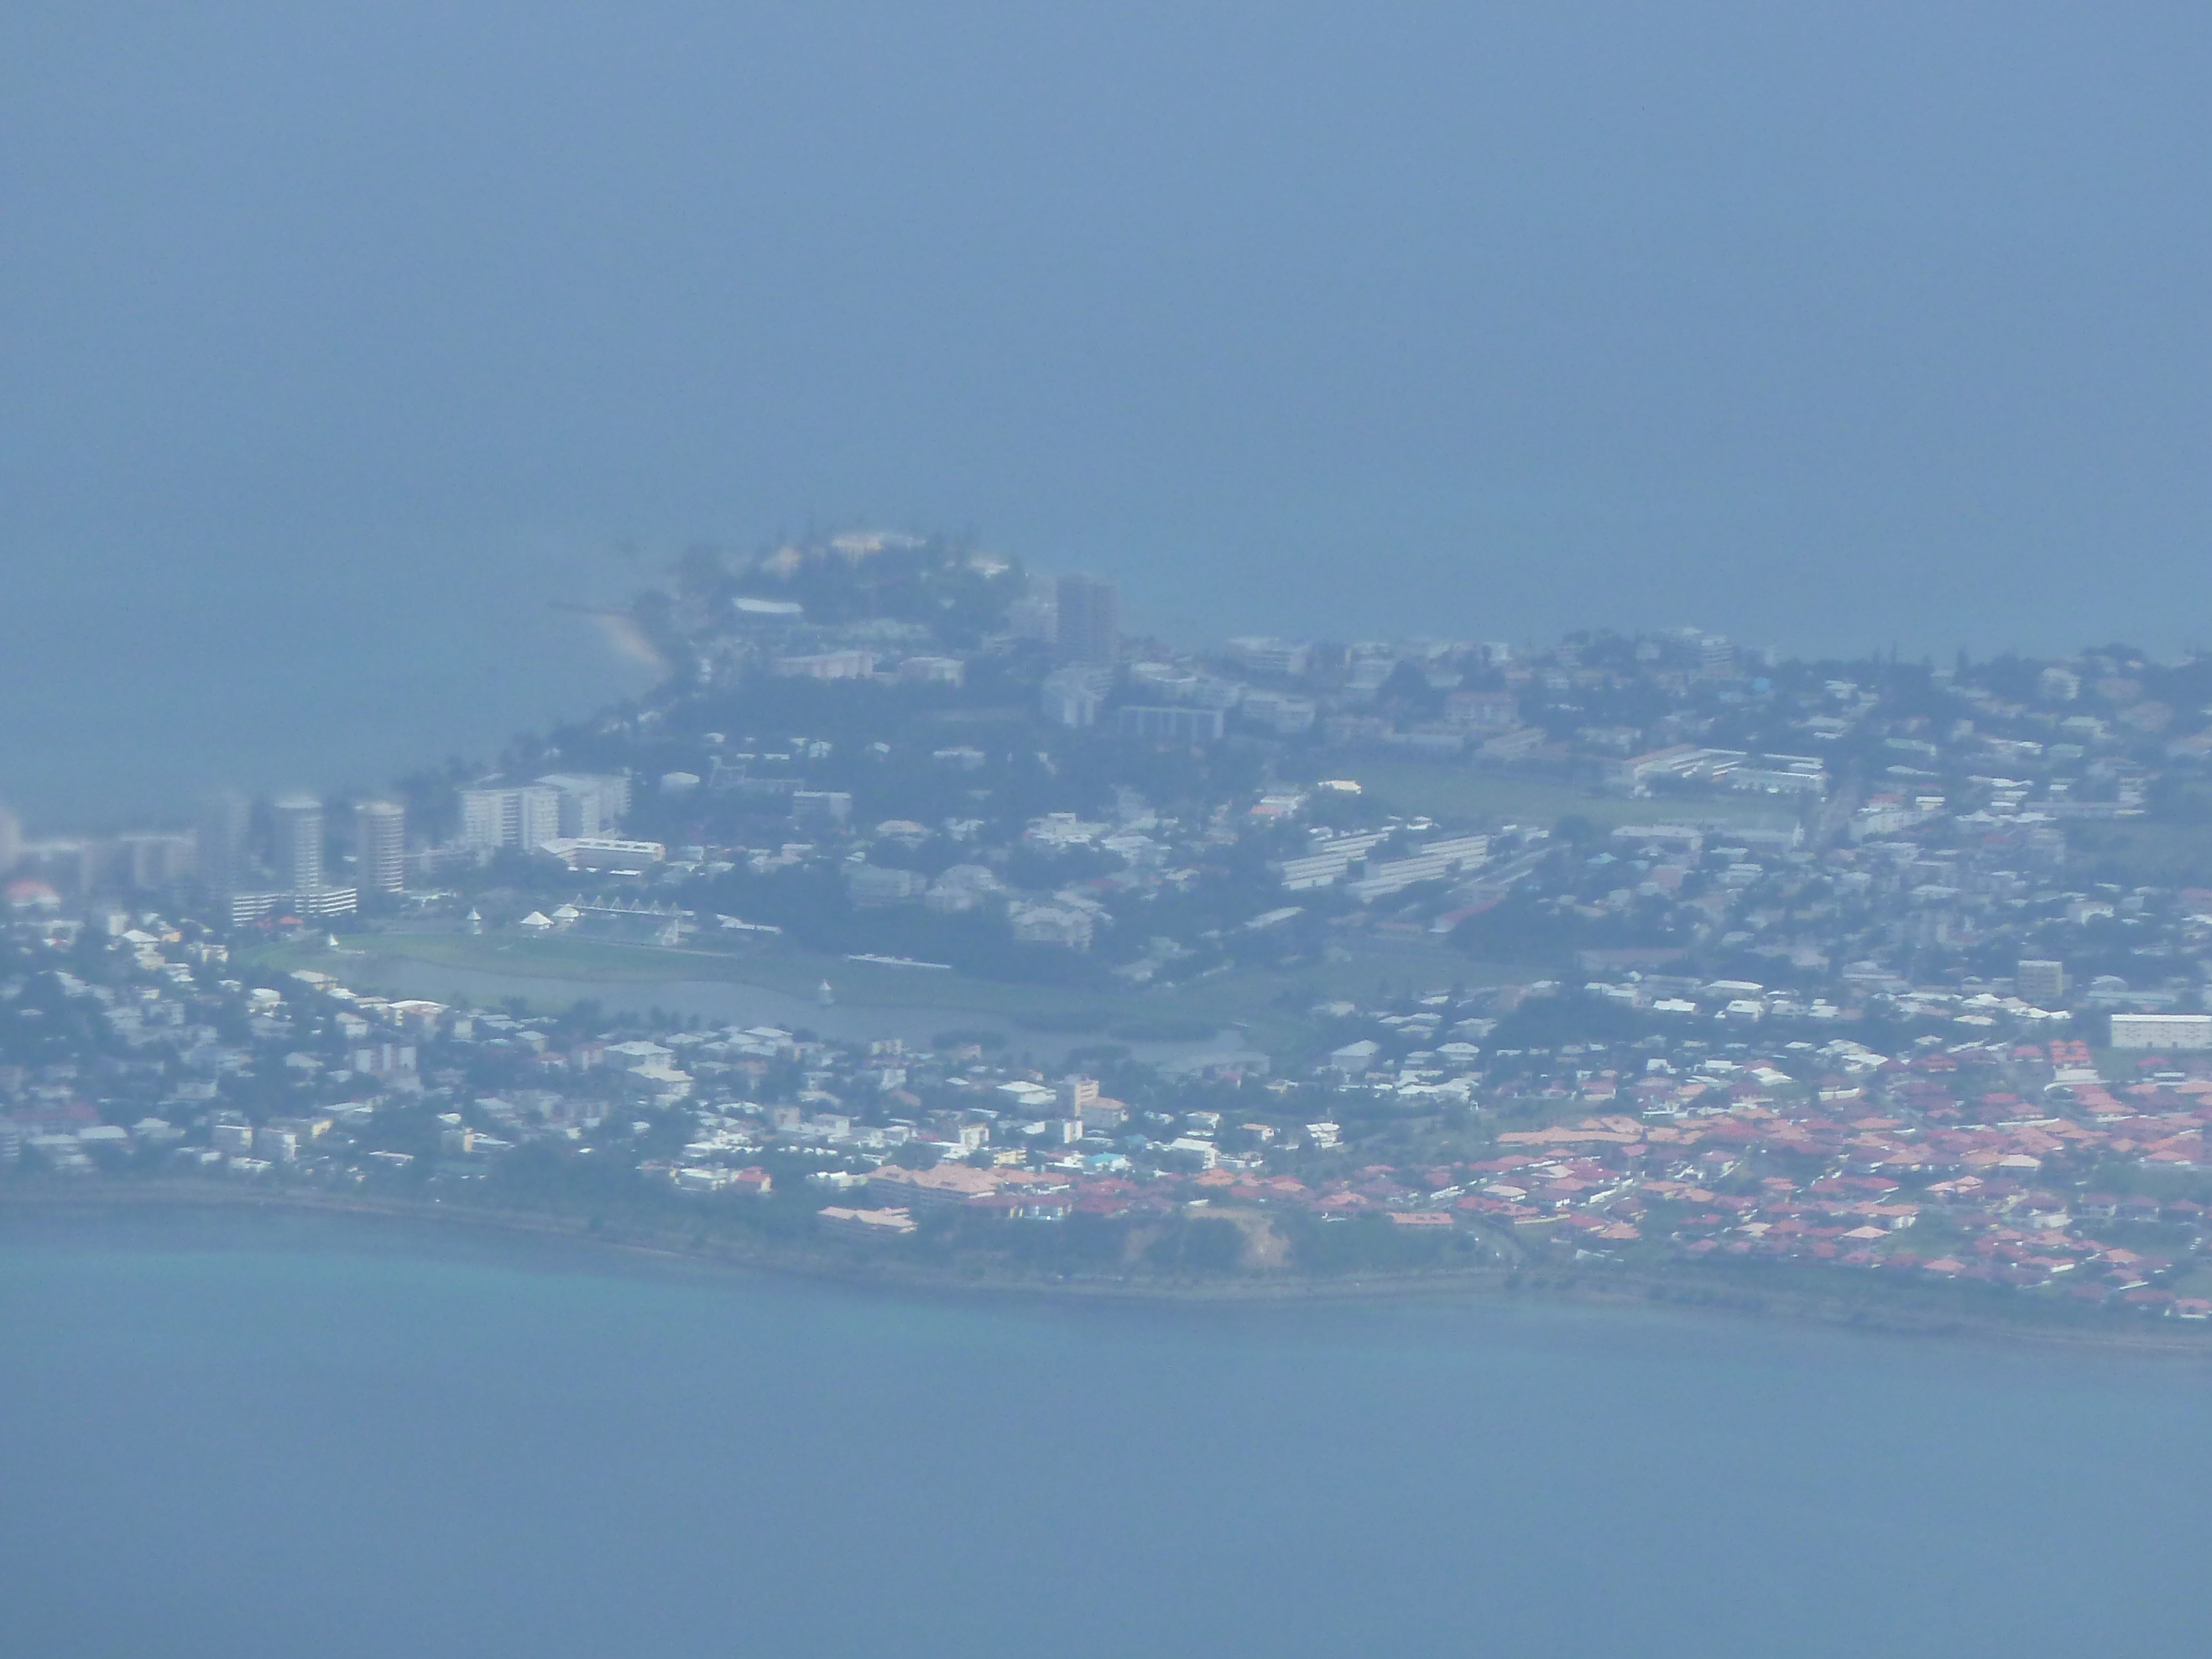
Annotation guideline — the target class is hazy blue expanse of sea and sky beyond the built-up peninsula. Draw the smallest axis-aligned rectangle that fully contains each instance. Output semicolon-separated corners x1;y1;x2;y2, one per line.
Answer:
0;4;2212;825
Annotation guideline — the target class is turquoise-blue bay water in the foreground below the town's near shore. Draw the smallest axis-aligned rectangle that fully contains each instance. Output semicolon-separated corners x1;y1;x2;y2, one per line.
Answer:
0;1217;2212;1659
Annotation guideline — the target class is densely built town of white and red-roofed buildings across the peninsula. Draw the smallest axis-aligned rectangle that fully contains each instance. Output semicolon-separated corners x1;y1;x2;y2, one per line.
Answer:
13;535;2212;1325
